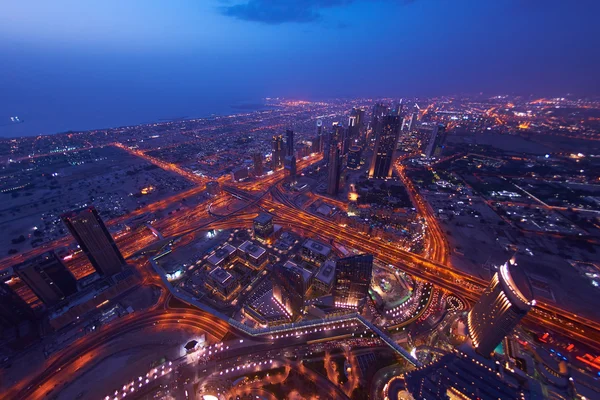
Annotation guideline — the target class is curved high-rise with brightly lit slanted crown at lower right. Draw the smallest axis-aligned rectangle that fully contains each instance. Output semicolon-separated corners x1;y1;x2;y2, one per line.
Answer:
467;262;535;356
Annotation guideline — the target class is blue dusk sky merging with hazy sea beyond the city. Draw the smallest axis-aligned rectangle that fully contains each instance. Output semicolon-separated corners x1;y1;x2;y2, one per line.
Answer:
0;0;600;136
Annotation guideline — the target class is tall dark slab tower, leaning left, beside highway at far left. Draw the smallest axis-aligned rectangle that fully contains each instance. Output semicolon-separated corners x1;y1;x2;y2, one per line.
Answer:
62;206;125;276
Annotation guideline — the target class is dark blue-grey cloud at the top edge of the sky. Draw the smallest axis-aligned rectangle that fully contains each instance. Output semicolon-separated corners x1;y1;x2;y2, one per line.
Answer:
220;0;355;25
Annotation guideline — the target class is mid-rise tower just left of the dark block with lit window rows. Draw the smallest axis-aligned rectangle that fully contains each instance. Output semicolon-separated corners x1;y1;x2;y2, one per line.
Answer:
271;261;311;321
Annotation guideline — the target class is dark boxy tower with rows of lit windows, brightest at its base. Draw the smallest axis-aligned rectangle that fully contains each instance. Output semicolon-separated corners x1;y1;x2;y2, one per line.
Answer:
333;254;373;308
